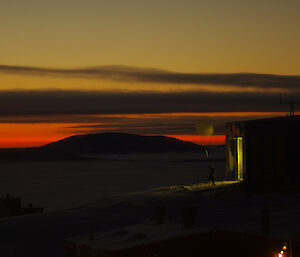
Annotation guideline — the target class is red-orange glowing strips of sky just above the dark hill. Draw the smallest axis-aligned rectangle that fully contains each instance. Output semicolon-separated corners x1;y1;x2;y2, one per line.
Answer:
0;112;292;148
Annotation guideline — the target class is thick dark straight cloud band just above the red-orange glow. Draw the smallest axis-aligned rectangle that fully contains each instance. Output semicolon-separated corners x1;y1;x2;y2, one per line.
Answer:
0;90;300;117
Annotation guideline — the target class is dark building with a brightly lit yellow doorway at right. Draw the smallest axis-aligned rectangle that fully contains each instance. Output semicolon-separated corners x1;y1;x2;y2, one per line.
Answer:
226;116;300;185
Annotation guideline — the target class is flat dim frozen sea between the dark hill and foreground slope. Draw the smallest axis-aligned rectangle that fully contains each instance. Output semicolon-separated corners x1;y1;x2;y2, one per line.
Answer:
0;151;225;211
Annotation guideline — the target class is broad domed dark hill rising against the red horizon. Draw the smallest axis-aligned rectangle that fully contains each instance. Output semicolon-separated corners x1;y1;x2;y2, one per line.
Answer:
39;133;204;154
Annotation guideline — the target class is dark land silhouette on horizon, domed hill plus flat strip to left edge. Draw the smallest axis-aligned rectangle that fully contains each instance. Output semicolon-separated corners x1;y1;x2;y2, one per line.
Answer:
0;133;205;161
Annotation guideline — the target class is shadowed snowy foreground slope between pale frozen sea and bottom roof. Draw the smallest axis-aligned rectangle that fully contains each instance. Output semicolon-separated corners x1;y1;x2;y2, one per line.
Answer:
0;180;300;257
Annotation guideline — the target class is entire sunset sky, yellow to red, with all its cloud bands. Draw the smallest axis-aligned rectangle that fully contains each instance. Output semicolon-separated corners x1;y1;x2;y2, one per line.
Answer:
0;0;300;147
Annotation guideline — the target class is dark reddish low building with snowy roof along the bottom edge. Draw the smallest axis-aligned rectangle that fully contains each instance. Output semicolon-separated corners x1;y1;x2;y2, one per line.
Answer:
64;224;300;257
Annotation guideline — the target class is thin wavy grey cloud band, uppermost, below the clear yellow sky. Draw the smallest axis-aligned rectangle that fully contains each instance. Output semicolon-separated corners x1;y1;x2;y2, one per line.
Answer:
0;65;300;91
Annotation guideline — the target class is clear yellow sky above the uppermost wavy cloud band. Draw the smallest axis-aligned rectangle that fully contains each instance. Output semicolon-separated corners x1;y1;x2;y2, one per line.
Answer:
0;0;300;75
